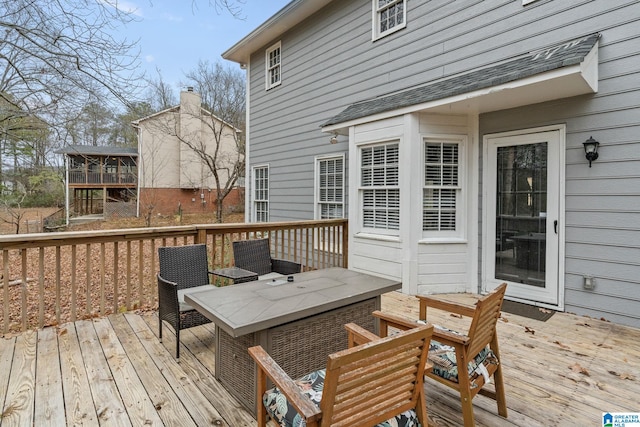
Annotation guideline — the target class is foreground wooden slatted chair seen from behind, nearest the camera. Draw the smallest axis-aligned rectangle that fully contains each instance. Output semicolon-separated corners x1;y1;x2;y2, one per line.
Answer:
249;323;433;427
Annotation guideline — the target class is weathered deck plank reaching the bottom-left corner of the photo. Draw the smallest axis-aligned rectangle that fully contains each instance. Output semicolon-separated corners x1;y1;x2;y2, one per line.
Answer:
2;331;38;427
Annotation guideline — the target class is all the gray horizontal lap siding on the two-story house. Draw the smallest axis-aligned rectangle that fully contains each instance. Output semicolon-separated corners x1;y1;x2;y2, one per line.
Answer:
234;0;640;326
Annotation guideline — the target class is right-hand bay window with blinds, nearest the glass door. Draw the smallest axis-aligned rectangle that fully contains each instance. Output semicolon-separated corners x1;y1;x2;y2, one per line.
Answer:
422;138;464;237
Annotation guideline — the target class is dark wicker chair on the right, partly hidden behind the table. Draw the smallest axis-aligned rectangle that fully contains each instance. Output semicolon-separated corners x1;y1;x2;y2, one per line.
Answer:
233;239;302;279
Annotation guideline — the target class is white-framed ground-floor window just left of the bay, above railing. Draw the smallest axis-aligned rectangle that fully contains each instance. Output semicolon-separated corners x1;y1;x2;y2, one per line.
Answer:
316;154;344;219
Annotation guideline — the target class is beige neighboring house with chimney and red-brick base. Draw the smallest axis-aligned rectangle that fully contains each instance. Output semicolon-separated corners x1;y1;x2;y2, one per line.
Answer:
133;88;243;216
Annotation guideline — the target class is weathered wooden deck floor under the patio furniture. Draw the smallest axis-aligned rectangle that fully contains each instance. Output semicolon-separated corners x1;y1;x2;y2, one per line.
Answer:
0;292;640;427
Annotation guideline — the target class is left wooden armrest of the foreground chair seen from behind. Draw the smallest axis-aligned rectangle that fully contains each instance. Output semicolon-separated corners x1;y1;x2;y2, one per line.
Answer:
249;345;322;423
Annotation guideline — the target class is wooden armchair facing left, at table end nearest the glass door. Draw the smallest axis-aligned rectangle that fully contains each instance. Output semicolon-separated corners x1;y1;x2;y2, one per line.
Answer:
373;283;507;427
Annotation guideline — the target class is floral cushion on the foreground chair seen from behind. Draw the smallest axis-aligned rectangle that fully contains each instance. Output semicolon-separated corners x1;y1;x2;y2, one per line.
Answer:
262;369;420;427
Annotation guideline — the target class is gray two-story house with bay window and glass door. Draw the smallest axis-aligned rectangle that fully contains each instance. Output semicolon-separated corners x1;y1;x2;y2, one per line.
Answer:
223;0;640;327
